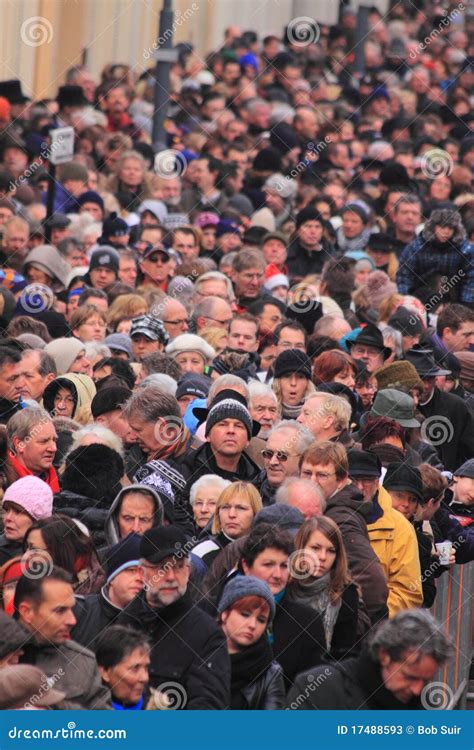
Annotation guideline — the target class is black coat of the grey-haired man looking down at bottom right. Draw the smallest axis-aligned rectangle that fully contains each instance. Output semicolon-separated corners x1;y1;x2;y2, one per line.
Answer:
287;650;423;711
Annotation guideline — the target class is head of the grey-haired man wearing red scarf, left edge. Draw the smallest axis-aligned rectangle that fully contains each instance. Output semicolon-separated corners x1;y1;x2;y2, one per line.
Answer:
7;407;57;474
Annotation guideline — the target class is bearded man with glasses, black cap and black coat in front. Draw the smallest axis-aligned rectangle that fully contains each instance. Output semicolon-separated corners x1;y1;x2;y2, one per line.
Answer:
118;526;230;710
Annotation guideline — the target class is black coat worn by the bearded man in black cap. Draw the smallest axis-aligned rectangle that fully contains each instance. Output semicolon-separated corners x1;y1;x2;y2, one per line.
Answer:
118;593;230;710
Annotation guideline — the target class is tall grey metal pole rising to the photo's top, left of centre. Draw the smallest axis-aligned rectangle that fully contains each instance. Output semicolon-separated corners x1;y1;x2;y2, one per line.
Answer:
152;0;174;153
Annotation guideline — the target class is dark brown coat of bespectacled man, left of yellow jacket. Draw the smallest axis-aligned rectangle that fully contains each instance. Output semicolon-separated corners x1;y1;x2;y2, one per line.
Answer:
325;484;388;622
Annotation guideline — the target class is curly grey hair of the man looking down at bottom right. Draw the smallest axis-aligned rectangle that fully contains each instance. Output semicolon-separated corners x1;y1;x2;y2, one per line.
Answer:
369;609;453;664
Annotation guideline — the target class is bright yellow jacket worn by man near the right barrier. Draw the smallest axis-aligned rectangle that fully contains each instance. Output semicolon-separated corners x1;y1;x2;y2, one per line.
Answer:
367;487;423;617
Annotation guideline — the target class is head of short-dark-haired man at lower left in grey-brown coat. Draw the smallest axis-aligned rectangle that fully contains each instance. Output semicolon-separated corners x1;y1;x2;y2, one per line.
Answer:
14;567;76;646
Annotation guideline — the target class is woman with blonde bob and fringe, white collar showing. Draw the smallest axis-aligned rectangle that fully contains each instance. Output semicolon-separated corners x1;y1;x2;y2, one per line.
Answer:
193;482;263;568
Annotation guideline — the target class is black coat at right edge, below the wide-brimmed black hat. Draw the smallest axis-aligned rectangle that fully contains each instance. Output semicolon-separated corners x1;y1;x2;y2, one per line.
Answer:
418;388;474;471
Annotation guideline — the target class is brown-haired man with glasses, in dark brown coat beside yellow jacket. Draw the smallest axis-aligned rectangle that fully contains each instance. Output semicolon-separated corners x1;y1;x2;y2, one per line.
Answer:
300;440;388;622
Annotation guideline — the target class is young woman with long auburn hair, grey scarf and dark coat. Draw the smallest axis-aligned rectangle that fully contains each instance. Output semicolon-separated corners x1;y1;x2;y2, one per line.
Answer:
288;516;359;659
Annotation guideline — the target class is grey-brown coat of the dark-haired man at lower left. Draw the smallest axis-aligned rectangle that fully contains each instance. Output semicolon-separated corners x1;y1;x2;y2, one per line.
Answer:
20;641;112;711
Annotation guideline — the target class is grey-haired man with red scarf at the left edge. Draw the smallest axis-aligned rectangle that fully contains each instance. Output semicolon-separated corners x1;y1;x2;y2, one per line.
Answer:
3;407;59;493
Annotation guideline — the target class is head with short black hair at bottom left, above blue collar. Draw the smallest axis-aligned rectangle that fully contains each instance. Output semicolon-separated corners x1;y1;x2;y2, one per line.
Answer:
95;624;150;708
